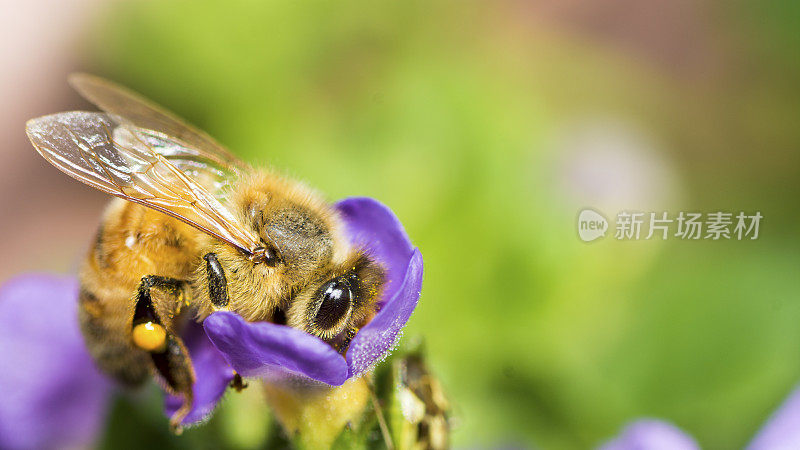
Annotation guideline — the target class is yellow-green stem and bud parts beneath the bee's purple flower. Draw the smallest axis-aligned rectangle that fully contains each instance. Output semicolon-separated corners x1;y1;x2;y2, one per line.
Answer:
265;342;450;449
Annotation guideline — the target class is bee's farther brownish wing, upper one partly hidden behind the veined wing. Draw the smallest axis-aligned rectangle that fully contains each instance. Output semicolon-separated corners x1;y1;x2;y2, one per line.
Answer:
69;73;250;172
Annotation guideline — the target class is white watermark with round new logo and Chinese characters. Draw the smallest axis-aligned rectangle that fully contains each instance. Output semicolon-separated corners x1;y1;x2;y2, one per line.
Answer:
578;208;764;242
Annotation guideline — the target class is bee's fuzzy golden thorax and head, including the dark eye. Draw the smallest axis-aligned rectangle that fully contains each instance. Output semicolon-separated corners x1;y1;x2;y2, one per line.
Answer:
195;178;385;346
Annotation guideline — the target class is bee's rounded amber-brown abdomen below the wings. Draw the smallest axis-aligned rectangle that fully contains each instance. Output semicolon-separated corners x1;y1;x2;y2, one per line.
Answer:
79;200;197;385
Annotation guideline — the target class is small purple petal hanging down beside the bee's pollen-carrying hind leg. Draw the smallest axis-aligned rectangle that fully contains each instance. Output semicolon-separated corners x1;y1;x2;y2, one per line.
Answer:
165;322;234;425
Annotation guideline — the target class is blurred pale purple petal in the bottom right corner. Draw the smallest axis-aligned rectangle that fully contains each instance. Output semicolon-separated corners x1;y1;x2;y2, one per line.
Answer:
747;388;800;450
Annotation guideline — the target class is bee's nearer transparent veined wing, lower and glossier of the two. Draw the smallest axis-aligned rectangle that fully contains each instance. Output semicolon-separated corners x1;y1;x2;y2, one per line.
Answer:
27;111;262;254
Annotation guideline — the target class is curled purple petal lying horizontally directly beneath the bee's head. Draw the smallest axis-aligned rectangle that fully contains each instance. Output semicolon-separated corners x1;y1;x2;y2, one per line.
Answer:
203;312;347;386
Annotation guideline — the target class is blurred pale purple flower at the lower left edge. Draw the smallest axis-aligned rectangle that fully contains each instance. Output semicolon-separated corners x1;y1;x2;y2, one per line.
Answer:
0;275;112;449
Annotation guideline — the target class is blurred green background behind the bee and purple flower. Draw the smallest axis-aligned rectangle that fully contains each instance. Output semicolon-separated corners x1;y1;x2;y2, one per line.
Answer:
1;0;800;449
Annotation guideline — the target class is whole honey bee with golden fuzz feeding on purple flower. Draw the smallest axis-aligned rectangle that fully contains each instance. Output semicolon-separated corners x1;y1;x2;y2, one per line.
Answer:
26;74;385;428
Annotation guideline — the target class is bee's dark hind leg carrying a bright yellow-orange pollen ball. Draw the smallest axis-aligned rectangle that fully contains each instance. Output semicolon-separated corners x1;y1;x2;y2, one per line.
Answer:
132;275;195;433
